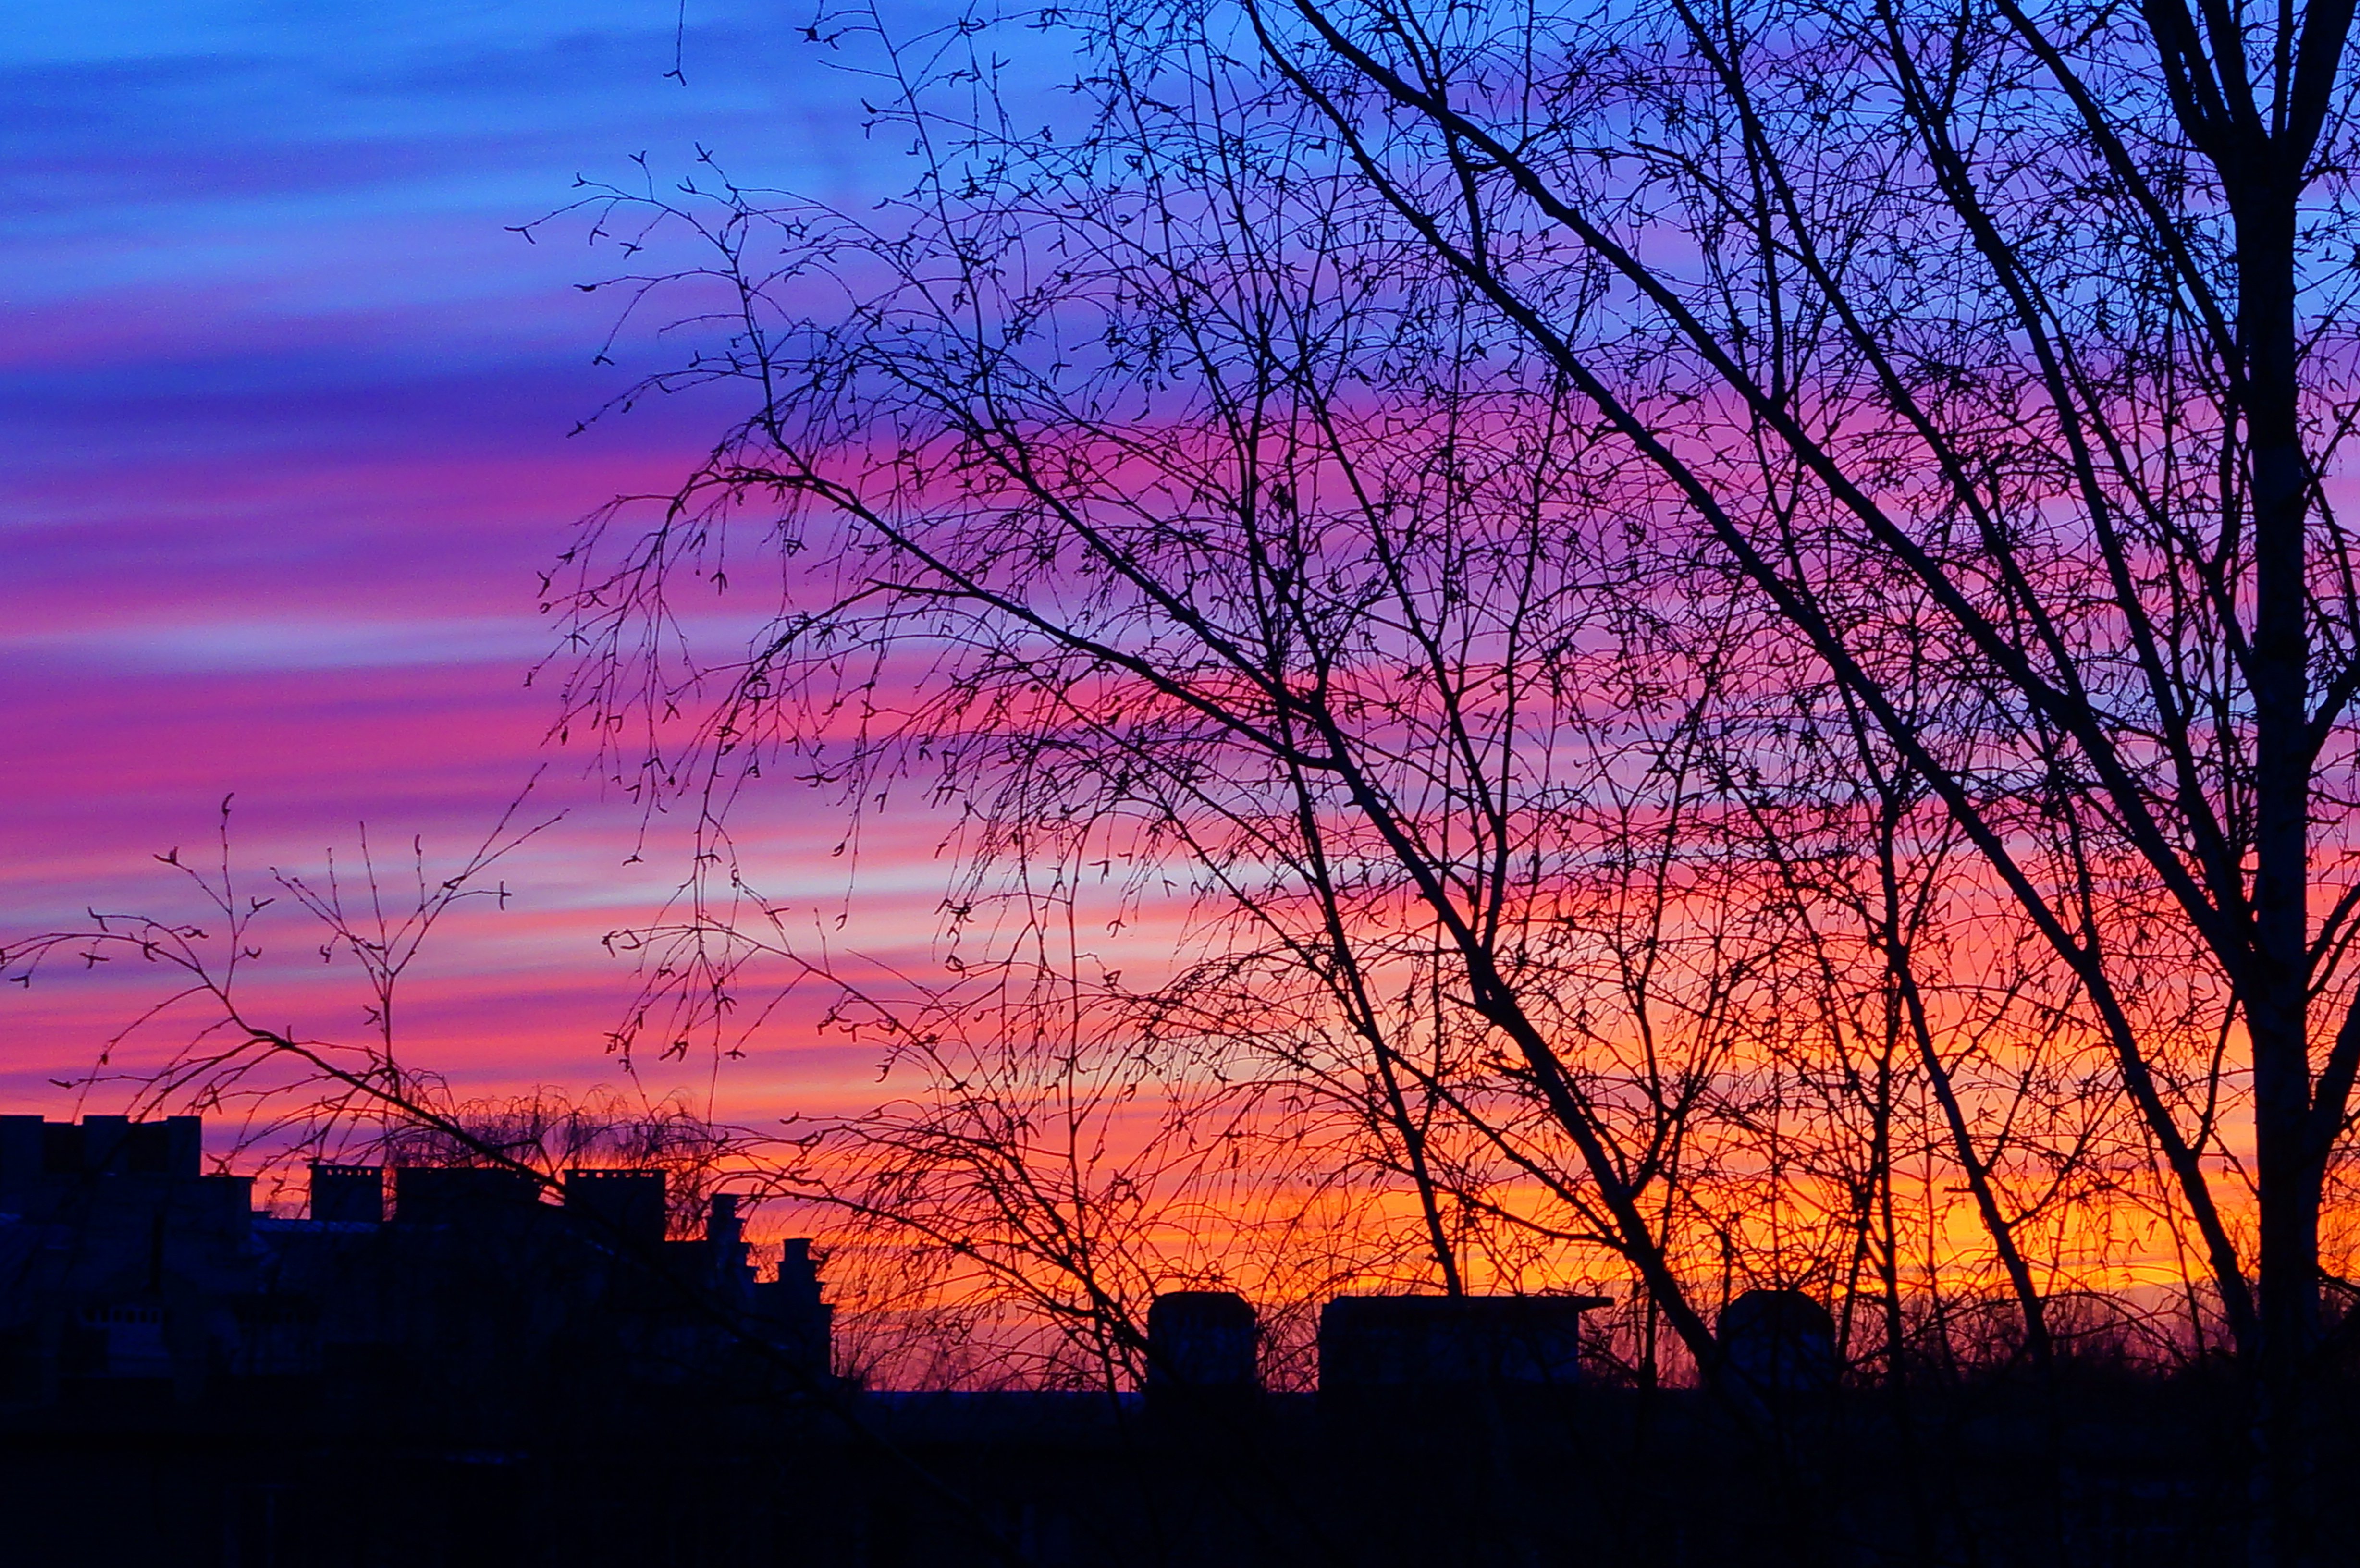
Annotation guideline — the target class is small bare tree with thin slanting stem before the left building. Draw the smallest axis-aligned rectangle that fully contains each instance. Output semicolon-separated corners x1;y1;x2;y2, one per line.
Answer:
0;803;1052;1563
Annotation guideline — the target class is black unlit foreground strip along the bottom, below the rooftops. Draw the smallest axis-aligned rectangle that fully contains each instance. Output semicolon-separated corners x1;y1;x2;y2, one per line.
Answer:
0;1377;2322;1568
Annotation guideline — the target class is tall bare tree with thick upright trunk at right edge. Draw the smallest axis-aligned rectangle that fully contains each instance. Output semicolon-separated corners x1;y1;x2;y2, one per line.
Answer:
1208;0;2360;1561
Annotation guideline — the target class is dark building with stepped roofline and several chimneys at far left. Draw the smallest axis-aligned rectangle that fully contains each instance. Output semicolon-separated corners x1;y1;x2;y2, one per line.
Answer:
0;1100;833;1408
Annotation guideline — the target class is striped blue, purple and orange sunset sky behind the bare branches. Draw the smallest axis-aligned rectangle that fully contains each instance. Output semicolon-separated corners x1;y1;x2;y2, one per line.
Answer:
0;0;2303;1407
